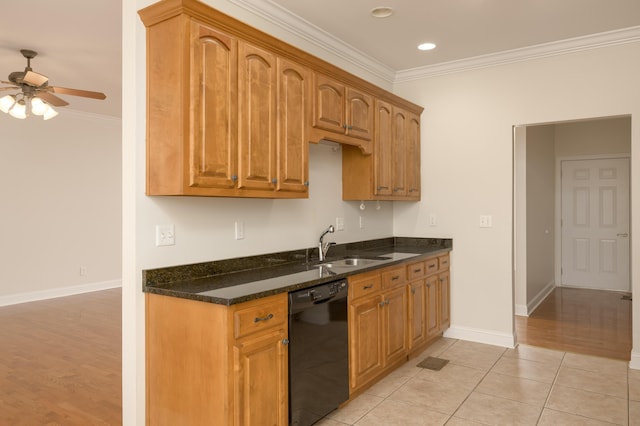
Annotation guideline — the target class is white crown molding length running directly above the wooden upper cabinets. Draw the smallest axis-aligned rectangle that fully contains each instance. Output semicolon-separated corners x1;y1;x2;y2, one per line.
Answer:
229;0;396;83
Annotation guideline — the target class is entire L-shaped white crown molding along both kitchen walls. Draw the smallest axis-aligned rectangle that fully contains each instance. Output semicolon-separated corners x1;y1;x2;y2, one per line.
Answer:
229;0;640;84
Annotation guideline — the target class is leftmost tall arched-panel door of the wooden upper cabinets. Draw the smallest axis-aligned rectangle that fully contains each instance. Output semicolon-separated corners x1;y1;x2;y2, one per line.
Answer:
192;23;238;189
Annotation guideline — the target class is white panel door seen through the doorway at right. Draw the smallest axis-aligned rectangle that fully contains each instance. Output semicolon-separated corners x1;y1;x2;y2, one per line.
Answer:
561;158;630;291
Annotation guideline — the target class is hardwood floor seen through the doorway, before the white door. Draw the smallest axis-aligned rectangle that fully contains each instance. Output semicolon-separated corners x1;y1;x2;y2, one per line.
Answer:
515;287;631;360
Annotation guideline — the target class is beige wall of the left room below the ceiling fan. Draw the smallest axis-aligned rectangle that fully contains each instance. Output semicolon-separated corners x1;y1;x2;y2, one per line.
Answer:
0;108;122;306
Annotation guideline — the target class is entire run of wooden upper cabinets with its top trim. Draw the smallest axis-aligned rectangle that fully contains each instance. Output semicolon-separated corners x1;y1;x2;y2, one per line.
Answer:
138;0;422;200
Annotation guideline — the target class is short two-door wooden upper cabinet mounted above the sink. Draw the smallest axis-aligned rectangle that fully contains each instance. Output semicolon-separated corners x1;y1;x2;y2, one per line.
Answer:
312;73;374;152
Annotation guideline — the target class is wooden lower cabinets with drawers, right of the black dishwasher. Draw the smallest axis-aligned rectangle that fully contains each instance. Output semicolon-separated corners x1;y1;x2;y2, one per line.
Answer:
349;254;450;397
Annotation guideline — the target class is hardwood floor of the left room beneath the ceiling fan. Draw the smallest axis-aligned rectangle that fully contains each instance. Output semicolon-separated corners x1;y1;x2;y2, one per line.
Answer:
0;289;122;426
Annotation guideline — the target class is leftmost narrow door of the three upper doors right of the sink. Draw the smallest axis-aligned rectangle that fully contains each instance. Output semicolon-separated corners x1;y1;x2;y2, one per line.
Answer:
373;101;393;195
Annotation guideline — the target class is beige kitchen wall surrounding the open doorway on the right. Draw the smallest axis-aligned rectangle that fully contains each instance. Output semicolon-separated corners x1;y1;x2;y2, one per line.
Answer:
394;43;640;356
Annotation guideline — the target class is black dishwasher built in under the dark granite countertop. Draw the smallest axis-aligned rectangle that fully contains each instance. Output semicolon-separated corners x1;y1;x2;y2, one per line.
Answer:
289;280;349;426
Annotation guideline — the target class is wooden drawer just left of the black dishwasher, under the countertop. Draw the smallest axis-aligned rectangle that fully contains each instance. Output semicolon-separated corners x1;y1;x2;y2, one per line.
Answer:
233;295;288;339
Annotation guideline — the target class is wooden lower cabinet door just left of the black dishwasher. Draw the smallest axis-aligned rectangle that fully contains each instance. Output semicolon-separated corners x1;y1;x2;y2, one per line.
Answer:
233;329;289;426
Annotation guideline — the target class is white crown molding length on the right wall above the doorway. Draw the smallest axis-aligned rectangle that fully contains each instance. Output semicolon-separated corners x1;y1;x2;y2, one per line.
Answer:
394;26;640;83
